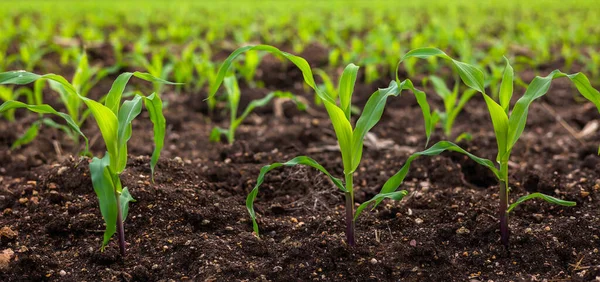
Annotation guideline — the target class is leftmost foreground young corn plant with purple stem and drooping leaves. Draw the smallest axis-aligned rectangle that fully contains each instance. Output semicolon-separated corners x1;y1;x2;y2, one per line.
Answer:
0;71;169;256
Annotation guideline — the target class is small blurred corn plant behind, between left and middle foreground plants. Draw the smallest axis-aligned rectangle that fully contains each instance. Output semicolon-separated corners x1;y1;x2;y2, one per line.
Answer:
210;75;306;144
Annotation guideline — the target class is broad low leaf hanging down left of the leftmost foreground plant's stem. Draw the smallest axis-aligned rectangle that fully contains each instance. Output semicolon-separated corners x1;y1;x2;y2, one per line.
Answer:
90;154;118;250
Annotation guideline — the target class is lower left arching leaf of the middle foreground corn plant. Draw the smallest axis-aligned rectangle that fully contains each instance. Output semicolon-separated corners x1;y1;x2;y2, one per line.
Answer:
246;156;346;236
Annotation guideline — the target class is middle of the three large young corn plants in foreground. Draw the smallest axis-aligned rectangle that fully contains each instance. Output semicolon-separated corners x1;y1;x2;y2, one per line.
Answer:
210;45;432;246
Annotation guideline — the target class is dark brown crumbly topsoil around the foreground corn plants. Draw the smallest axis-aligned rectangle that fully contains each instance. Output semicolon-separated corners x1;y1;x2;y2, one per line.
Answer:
0;48;600;281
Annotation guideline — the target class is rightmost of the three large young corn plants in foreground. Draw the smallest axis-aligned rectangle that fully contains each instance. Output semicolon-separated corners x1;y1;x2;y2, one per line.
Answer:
380;48;600;248
